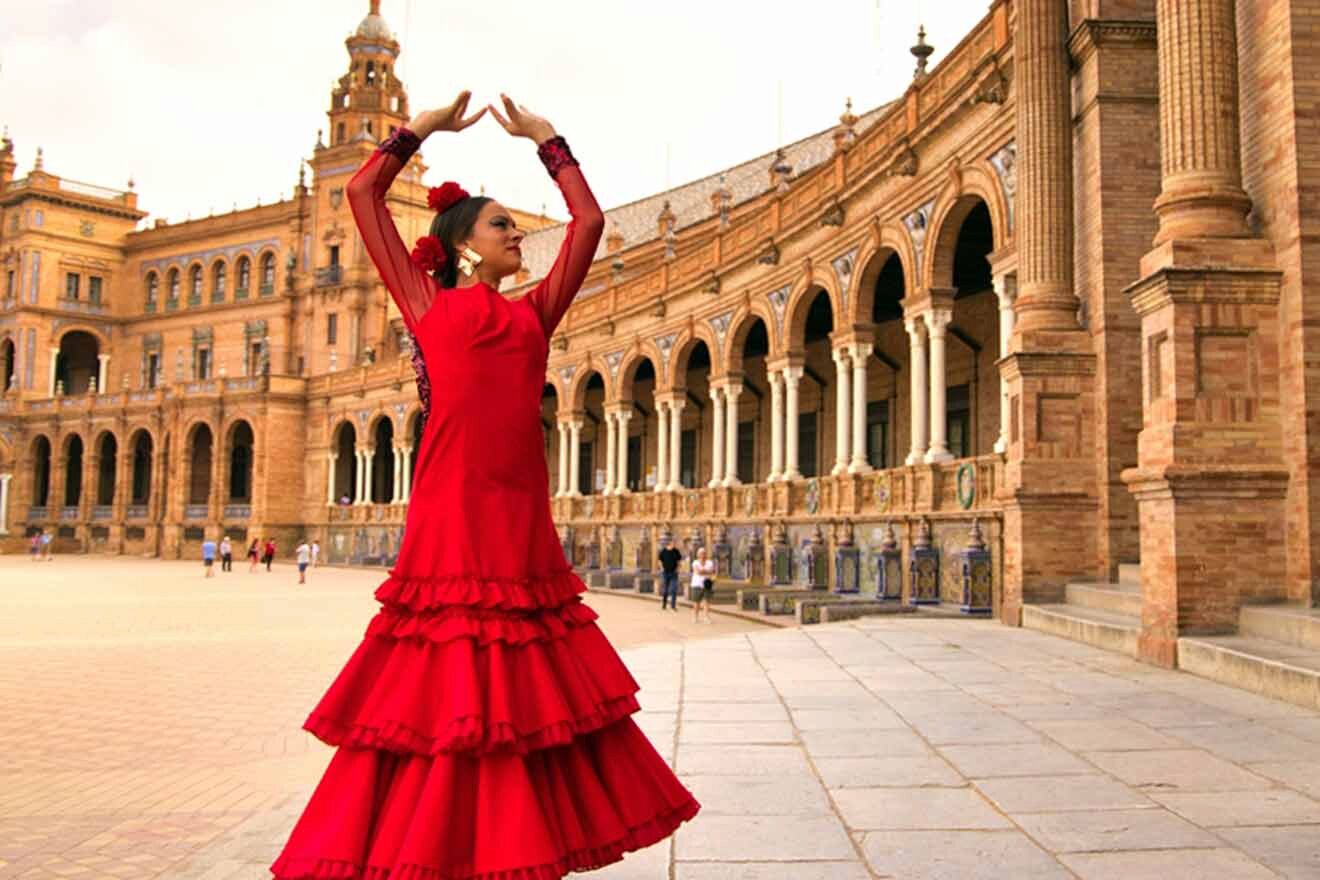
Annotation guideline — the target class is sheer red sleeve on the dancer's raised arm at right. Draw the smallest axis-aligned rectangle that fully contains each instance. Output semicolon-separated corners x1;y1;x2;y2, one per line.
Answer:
527;137;605;336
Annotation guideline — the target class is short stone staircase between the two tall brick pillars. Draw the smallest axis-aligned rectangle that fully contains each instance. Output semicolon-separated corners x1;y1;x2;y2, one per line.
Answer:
1022;565;1142;657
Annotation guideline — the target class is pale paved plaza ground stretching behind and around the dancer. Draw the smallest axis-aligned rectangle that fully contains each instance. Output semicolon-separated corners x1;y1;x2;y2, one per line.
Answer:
0;557;1320;880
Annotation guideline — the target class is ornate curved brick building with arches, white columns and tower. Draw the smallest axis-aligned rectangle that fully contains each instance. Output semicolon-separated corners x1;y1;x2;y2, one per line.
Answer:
0;0;1320;680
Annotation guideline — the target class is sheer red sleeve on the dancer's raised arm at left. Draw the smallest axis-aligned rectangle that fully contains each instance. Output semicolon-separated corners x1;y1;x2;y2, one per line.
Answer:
348;128;438;332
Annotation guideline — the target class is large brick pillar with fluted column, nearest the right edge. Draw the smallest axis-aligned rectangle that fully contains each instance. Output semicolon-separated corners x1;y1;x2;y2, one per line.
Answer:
1123;0;1288;666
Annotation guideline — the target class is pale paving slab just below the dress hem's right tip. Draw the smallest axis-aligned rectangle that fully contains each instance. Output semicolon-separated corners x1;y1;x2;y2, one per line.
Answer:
675;815;855;862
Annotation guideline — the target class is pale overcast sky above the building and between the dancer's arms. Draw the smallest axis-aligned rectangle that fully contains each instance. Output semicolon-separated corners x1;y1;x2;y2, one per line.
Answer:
0;0;990;222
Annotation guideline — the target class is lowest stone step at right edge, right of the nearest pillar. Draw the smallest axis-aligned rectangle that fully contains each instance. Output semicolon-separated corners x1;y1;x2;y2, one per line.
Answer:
1177;636;1320;708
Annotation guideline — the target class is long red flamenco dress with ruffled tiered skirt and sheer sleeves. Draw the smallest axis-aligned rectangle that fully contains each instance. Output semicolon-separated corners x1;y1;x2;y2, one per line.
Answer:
271;129;700;880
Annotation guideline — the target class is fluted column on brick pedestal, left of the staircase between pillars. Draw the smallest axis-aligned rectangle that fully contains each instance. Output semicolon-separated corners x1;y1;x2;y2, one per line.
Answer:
999;0;1098;625
